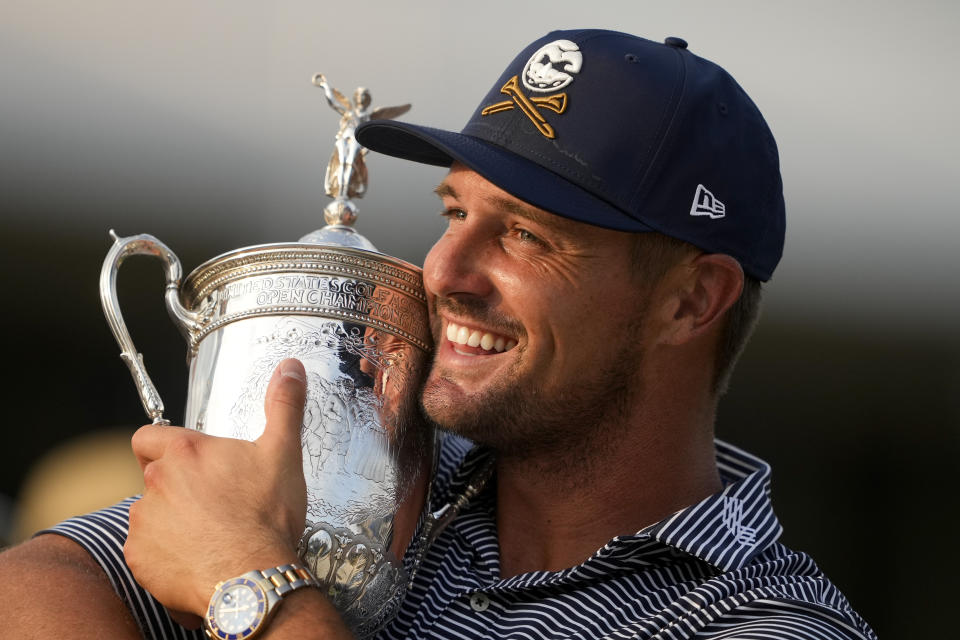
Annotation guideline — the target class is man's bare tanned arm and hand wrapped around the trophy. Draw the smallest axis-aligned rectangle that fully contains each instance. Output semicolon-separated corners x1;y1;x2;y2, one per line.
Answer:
0;361;349;640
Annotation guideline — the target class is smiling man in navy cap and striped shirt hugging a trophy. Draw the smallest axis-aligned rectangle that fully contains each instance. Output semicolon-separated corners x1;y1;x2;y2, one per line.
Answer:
4;30;874;638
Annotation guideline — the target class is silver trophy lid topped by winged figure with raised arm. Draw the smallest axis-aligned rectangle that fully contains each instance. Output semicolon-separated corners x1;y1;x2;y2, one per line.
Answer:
300;73;410;253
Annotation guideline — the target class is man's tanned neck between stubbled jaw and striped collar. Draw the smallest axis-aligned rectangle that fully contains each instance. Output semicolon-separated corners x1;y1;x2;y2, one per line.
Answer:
497;412;721;577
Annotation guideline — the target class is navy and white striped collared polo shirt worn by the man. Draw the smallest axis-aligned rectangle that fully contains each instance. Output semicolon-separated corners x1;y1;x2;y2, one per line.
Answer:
51;438;876;640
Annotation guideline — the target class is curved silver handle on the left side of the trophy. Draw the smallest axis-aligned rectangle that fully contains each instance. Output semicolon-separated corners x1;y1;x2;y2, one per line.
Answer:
100;229;197;424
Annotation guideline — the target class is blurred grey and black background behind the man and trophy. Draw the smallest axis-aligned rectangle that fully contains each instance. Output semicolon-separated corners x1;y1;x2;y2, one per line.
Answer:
0;0;960;638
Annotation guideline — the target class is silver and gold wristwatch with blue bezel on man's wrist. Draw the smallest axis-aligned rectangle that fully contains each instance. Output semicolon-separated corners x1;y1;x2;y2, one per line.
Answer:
203;564;320;640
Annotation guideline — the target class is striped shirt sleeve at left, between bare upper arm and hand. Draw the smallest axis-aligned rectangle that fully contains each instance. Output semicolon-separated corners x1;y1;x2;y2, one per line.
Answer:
37;496;204;640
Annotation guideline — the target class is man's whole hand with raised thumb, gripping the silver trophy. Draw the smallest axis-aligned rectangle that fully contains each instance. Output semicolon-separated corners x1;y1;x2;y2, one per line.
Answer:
124;360;307;619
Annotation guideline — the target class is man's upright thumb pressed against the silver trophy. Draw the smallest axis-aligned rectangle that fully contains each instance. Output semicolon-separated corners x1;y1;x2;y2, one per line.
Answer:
257;358;307;457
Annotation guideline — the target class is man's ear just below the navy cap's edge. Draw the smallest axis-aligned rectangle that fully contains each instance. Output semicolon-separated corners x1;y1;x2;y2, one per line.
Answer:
664;253;744;345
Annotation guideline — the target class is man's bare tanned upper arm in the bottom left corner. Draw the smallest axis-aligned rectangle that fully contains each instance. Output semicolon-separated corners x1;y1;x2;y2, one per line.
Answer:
0;534;140;640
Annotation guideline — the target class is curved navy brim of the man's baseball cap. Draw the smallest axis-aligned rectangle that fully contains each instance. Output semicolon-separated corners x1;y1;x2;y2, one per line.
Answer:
356;120;654;232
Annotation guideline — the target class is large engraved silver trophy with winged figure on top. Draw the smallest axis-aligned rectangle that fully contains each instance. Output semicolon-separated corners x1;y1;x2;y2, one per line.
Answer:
100;74;433;637
